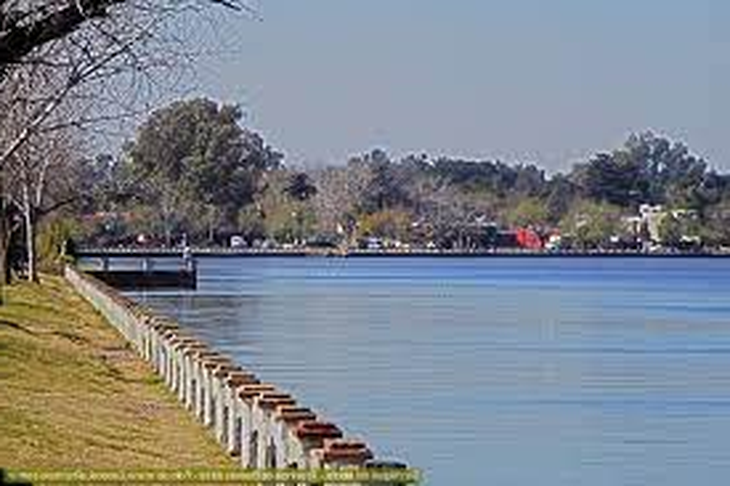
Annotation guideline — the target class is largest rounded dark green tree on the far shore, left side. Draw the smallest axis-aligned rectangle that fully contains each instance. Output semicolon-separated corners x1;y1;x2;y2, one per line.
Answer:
127;99;282;244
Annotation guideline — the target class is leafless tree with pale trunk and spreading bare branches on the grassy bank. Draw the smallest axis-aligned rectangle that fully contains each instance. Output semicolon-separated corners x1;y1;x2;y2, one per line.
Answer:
0;0;242;288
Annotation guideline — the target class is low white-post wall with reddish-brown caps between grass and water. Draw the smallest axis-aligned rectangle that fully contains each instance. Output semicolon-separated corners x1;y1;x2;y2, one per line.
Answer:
65;266;393;469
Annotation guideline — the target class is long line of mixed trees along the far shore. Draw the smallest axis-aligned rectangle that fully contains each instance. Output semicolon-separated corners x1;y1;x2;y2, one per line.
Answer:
73;99;730;252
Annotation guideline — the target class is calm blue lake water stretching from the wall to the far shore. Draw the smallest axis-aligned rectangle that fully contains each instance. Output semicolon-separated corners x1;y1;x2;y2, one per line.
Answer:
126;258;730;486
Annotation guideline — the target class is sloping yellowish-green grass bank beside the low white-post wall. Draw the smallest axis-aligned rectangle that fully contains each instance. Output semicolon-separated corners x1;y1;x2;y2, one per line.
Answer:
0;277;232;468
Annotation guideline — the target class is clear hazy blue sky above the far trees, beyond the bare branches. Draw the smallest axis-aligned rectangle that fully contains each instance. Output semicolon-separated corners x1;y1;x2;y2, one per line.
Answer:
192;0;730;170
